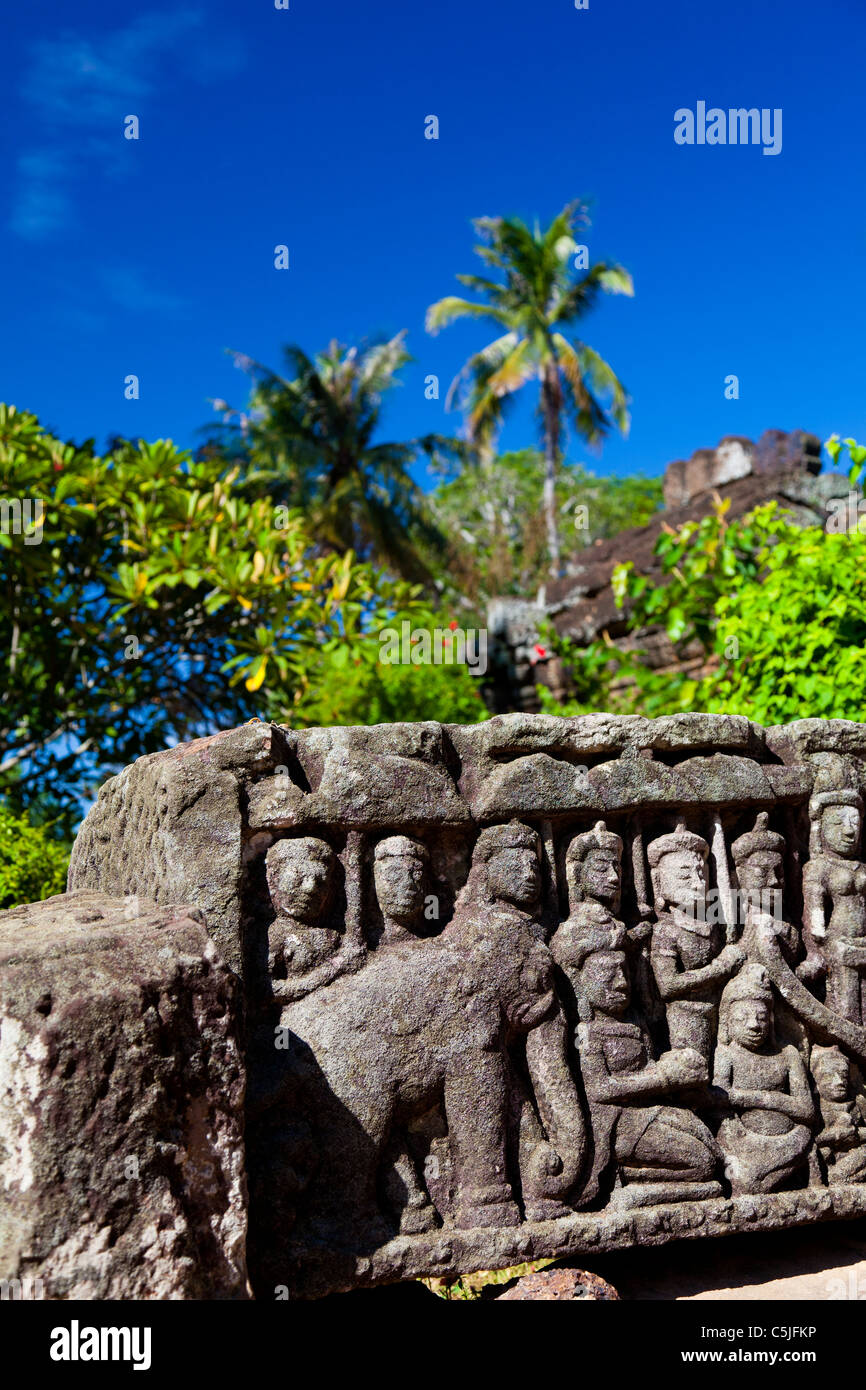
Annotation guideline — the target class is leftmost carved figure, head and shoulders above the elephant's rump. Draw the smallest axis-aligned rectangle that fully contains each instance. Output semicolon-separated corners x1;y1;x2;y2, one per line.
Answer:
265;837;359;1001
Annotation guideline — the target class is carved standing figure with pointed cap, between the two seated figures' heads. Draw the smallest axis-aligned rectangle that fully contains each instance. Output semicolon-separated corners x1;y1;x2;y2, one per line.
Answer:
646;821;745;1080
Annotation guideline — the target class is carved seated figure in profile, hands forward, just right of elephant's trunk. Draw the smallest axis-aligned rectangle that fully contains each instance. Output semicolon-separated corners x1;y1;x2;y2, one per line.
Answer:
566;923;721;1205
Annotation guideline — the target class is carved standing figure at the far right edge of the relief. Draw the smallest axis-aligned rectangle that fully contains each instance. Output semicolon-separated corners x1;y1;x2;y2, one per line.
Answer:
801;780;866;1024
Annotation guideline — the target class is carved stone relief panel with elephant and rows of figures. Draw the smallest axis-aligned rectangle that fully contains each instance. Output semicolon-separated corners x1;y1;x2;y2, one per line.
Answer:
64;714;866;1297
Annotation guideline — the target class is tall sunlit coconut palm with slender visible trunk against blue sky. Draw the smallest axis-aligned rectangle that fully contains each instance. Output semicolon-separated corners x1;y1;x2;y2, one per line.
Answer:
427;202;634;575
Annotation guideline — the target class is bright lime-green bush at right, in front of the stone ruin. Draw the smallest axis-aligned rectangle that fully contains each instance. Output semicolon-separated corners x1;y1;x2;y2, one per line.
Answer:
542;441;866;724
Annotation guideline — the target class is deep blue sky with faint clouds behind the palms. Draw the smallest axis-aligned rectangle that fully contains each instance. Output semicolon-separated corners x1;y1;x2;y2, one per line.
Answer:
0;0;866;486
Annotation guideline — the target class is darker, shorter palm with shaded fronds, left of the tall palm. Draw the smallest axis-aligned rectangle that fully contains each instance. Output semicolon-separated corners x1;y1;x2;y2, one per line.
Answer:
214;334;461;582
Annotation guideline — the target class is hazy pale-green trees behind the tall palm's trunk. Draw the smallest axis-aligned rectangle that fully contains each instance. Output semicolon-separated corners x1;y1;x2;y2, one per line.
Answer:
430;449;662;609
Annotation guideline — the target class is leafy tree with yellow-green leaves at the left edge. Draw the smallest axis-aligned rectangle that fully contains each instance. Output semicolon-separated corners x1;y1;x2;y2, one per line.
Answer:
0;406;480;802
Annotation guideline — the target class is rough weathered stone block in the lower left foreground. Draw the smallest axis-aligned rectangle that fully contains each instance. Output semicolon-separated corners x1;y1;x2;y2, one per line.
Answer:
0;892;249;1300
